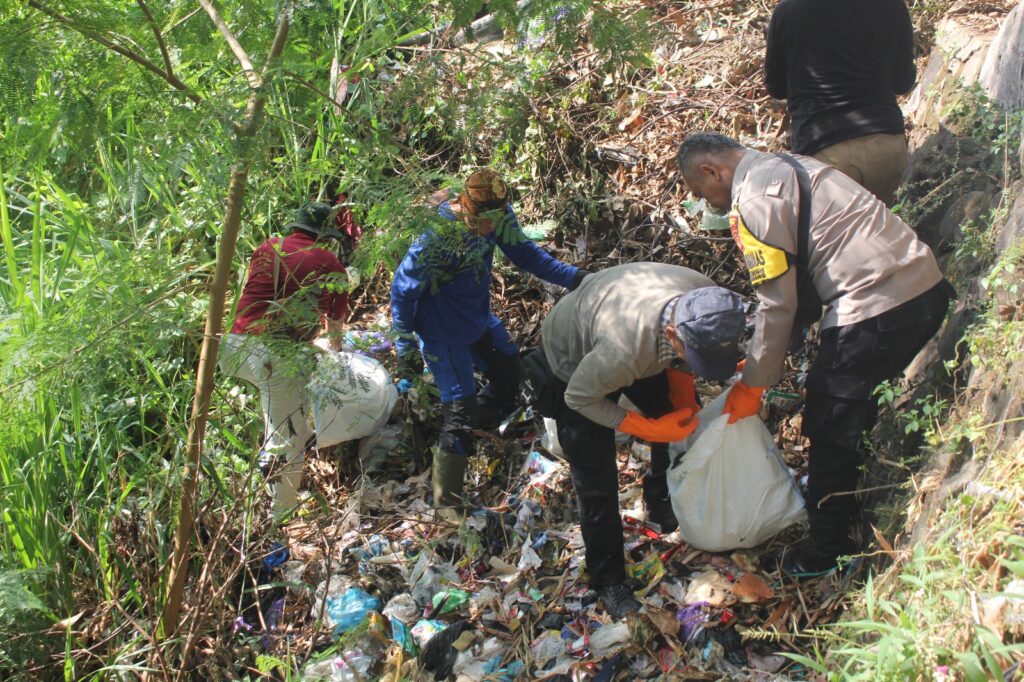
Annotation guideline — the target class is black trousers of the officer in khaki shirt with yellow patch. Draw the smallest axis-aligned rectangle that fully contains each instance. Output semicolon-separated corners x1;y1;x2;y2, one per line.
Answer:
804;280;955;545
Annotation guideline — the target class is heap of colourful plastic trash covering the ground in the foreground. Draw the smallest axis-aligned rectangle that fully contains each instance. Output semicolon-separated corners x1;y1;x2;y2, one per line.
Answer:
243;368;839;681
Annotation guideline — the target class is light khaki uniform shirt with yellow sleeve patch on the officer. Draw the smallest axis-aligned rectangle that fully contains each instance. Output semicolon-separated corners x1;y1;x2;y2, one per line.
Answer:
729;150;942;386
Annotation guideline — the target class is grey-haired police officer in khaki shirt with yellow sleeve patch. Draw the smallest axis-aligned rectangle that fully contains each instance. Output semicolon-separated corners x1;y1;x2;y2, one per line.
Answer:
678;133;954;576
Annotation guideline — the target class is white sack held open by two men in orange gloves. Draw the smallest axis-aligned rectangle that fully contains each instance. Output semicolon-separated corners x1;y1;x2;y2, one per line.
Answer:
669;385;804;552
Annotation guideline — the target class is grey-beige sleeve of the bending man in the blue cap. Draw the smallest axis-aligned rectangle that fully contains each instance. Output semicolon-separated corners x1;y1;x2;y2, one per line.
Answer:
565;346;636;429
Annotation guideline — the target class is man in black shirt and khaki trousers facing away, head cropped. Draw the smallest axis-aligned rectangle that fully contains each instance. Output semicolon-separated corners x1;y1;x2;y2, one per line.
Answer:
765;0;916;206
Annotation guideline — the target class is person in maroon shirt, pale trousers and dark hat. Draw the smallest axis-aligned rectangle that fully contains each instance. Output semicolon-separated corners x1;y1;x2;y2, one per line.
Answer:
220;202;348;519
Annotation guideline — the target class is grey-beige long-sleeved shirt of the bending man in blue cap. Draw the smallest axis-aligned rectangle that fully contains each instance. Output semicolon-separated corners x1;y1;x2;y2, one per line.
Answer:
541;263;715;428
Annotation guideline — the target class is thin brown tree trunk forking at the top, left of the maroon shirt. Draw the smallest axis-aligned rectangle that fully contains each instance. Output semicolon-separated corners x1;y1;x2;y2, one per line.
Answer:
160;7;290;637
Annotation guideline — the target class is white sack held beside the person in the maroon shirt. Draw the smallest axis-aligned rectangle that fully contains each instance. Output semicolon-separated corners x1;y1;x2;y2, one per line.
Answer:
308;350;398;447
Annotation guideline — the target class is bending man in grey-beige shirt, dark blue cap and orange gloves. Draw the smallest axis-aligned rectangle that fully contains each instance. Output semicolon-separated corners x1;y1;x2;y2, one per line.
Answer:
524;263;745;619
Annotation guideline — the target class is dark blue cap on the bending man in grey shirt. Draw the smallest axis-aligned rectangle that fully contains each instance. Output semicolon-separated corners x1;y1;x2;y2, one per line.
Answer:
673;287;746;381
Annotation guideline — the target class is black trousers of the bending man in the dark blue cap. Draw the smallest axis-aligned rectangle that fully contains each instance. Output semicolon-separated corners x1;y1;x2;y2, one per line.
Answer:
525;348;673;588
